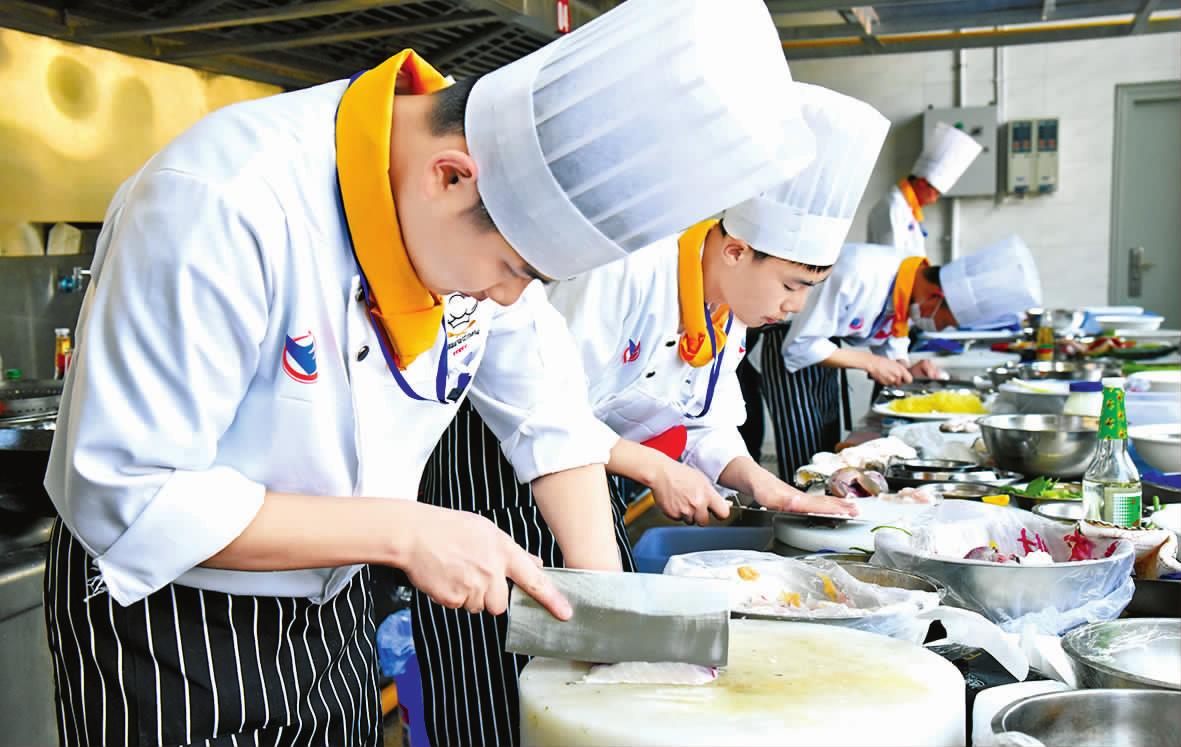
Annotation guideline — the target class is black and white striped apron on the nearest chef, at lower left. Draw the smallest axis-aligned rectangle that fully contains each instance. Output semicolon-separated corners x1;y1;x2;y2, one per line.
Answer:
45;519;381;747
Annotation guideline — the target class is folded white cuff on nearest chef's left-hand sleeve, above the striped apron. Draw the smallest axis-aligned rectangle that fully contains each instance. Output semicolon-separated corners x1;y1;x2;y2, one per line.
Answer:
94;467;266;607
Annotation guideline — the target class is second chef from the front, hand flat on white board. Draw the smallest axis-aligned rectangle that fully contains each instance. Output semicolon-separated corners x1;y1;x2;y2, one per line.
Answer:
413;84;888;745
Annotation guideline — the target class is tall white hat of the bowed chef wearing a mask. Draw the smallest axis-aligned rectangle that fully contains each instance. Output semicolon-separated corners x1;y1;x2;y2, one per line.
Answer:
939;236;1042;327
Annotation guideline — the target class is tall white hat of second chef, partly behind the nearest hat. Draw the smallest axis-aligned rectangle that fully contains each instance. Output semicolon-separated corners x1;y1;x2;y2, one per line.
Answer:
723;83;889;267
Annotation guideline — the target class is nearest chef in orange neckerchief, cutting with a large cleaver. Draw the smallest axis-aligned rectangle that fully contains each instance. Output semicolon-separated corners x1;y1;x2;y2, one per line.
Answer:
45;0;810;745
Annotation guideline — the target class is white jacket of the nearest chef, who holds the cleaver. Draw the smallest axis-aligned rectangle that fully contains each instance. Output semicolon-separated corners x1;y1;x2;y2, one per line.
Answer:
45;81;615;604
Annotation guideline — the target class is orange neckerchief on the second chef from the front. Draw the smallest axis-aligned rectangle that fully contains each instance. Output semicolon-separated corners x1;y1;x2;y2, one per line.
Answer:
677;221;730;368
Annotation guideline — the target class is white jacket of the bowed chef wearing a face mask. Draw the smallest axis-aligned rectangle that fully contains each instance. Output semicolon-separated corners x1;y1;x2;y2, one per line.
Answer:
781;244;913;373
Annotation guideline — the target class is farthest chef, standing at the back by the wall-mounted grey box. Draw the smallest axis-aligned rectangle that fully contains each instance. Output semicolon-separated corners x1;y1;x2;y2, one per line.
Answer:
866;122;983;256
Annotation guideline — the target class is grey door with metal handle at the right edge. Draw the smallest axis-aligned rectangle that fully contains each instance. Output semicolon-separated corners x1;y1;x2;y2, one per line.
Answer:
1109;80;1181;329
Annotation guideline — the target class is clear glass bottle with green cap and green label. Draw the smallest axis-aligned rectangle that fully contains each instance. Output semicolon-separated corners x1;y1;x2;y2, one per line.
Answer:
1083;379;1143;526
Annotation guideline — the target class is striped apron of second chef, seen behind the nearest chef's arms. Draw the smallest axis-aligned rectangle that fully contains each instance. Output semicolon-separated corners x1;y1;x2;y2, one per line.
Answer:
413;402;635;747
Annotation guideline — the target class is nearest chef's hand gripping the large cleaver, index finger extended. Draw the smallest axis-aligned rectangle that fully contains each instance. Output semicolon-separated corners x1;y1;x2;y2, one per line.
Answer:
399;504;572;620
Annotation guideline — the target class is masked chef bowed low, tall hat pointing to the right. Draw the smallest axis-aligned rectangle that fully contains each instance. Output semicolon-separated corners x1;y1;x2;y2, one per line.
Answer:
763;236;1042;476
